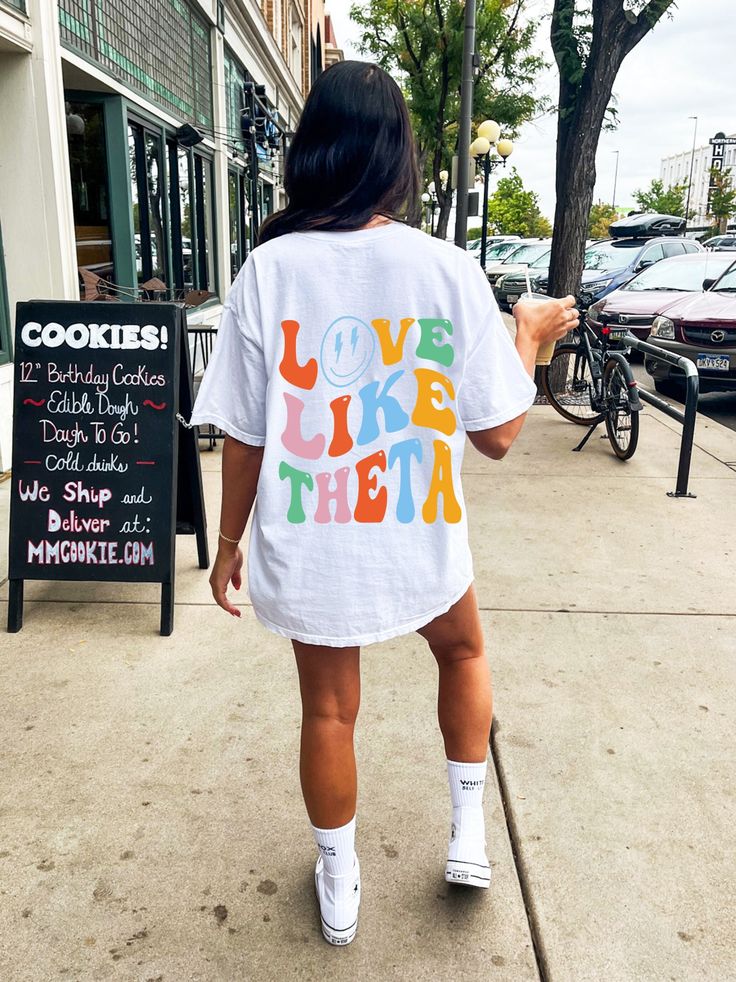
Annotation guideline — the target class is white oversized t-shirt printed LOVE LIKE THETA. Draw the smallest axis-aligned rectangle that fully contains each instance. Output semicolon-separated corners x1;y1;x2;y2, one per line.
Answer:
192;222;536;646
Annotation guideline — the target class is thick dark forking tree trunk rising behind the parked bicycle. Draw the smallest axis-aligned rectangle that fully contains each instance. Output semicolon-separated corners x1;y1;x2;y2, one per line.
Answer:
550;0;674;296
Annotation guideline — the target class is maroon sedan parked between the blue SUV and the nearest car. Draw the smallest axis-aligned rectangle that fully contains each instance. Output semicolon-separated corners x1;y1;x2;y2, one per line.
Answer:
587;252;736;341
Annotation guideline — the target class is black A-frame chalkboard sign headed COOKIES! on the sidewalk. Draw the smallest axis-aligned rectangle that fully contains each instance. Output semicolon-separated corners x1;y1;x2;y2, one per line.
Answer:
8;301;209;634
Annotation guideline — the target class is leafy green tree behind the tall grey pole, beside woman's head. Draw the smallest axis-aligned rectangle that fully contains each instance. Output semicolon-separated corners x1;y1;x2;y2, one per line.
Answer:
350;0;546;239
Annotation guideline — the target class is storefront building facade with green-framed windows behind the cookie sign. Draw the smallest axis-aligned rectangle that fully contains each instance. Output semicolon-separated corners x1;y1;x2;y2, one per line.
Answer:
0;0;334;473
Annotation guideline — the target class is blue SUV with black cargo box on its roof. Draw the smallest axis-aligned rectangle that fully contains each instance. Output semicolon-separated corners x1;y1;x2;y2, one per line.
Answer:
539;237;703;310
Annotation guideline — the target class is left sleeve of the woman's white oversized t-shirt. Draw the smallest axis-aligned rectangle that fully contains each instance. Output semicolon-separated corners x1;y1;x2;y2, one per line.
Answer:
191;262;267;447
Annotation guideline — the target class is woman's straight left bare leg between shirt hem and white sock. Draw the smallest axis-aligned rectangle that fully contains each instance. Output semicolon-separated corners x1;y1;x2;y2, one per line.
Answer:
292;641;360;829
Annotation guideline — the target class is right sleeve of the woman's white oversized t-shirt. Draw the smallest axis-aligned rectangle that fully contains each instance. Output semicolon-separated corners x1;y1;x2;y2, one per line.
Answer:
457;266;537;431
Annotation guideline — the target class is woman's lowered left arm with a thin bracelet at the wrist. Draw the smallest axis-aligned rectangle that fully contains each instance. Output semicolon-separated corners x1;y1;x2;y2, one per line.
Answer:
210;436;263;617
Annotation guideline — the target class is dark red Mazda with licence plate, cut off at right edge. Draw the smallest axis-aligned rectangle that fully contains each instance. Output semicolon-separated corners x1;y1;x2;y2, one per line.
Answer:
644;263;736;394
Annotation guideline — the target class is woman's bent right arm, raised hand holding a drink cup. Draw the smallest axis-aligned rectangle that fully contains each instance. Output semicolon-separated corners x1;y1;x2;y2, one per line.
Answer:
468;296;580;460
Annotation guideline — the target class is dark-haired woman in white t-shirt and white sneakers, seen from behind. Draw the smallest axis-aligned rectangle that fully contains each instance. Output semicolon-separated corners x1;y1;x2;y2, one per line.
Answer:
192;61;578;945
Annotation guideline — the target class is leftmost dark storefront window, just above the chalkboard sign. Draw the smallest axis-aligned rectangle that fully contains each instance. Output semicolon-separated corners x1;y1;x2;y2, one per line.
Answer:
66;101;115;292
